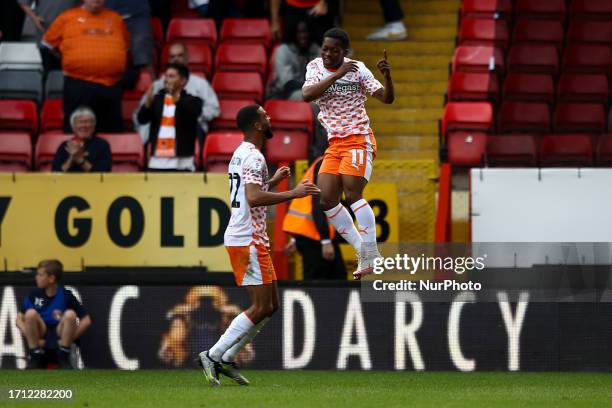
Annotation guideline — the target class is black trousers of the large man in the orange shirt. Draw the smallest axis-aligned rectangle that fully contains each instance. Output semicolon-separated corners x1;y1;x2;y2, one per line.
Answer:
64;76;123;133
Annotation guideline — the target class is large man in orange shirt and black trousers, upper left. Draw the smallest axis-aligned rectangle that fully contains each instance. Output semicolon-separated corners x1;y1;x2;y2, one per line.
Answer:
43;0;129;133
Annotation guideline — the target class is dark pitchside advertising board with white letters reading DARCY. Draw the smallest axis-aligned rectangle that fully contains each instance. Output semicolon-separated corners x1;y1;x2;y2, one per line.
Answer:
0;284;612;371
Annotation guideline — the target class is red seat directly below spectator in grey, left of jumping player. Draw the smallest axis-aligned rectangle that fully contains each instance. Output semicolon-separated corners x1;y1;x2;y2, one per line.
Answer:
264;100;314;135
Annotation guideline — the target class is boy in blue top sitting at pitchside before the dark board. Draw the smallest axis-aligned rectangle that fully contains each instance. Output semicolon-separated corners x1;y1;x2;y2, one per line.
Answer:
16;259;91;369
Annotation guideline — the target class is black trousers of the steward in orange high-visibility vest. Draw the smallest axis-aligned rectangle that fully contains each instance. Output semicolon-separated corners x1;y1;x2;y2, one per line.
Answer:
295;235;346;280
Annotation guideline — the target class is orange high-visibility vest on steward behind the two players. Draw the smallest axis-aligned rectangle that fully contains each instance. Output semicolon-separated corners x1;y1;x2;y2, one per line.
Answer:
283;157;335;241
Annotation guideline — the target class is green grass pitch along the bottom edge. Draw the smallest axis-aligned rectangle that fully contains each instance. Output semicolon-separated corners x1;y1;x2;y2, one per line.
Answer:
0;370;612;408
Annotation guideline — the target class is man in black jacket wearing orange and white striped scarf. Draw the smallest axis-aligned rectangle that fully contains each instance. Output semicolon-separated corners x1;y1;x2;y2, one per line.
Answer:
138;63;203;171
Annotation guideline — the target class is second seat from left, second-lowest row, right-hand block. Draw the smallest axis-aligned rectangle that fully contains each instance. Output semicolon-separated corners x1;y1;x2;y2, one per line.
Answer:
498;101;550;133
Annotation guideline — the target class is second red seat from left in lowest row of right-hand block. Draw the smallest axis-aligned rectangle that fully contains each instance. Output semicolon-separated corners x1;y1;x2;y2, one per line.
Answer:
486;133;538;167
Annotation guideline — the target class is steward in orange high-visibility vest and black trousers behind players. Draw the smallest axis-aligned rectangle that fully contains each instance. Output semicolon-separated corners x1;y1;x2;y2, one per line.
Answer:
283;157;346;280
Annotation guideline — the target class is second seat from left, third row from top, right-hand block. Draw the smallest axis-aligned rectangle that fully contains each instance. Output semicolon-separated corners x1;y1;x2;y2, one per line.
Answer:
508;44;559;75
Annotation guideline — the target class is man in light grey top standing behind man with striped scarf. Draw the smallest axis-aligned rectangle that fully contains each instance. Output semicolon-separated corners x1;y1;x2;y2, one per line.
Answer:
133;43;221;143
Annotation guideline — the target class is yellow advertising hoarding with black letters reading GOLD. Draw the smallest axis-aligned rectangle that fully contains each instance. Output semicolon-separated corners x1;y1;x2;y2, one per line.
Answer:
0;173;230;271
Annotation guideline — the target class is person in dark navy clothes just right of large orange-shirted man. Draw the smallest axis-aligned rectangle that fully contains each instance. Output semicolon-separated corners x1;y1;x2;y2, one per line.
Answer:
105;0;153;72
